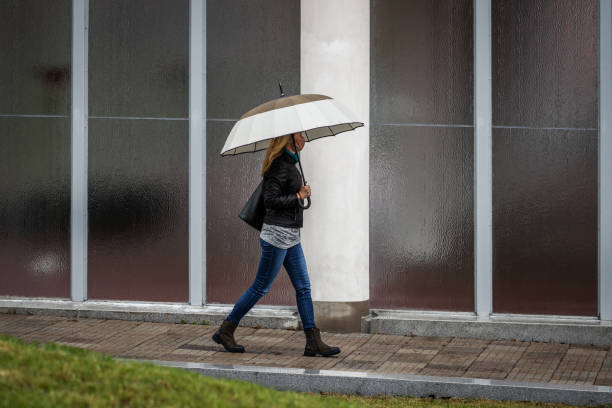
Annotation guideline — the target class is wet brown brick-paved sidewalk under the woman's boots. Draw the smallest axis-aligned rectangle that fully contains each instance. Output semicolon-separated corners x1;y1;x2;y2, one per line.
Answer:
0;314;612;386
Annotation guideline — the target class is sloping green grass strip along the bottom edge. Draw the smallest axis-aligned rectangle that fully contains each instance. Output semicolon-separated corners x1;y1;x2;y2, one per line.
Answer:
0;335;588;408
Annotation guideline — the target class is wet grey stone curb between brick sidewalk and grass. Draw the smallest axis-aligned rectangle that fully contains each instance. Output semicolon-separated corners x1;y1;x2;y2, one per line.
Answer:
138;360;612;405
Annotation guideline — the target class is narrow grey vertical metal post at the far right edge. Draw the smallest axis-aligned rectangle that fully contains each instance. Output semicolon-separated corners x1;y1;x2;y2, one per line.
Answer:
598;0;612;324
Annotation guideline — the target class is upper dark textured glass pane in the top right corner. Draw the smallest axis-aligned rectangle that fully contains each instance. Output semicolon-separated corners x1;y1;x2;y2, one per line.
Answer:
492;0;598;128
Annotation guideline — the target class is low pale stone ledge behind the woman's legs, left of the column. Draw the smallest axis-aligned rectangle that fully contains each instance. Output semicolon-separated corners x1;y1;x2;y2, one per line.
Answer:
0;299;298;330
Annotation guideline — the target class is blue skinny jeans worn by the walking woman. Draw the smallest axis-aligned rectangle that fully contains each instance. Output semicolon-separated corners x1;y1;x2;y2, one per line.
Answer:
227;238;315;329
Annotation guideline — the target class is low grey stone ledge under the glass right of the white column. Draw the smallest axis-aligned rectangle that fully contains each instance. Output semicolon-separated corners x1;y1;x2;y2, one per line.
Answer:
362;312;612;346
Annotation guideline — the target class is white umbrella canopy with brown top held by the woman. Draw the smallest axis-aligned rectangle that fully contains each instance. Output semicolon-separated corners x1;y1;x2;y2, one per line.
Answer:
221;94;363;156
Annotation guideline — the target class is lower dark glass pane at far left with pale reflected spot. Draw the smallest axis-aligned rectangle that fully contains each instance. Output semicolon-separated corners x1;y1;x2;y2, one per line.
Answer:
0;118;70;298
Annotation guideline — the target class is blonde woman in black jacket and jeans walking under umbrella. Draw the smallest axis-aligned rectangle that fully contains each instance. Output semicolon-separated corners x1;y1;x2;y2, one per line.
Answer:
213;133;340;356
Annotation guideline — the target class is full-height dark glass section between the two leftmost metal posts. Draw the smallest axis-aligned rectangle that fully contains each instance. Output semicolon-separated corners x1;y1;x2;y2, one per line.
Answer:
87;0;189;302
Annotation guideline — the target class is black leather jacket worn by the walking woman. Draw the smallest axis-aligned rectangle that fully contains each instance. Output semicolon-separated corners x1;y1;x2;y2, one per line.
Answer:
263;151;304;228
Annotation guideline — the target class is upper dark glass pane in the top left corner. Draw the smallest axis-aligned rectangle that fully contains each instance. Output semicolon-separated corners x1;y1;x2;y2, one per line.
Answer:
0;0;72;115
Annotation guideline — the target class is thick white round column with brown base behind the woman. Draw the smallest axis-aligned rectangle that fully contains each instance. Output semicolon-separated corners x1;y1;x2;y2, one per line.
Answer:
301;0;370;331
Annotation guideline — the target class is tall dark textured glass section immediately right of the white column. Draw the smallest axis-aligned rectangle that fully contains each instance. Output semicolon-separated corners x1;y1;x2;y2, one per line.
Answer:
370;0;474;311
